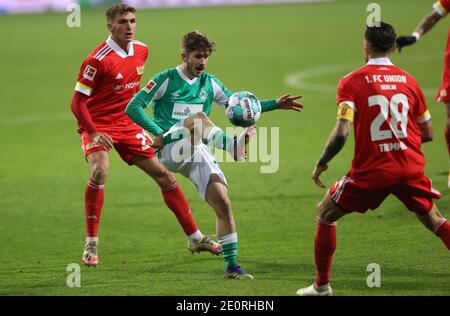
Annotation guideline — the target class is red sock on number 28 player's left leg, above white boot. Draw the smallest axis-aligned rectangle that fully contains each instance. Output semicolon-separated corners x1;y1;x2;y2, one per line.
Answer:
314;218;336;285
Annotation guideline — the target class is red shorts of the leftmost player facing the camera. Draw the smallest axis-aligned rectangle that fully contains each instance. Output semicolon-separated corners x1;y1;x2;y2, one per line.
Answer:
80;127;156;165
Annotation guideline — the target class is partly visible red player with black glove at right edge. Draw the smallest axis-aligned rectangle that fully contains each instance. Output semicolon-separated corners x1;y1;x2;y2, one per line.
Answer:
397;0;450;189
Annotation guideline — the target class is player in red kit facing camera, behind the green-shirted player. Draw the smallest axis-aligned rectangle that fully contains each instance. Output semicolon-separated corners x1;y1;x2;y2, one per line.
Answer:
71;4;221;266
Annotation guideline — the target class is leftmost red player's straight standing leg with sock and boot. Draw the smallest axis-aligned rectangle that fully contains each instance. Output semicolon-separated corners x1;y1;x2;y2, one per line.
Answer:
82;151;109;267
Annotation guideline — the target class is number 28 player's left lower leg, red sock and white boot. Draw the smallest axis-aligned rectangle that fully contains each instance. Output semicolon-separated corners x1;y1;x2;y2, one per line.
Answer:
297;192;346;296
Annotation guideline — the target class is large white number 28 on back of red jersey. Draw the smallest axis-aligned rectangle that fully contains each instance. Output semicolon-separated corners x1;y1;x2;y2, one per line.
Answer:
369;93;409;141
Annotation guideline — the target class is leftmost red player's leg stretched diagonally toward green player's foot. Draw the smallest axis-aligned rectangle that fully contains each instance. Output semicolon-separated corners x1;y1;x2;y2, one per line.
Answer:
132;157;222;255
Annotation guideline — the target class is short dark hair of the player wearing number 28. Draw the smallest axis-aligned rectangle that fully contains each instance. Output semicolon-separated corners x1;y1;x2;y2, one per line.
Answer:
364;22;397;53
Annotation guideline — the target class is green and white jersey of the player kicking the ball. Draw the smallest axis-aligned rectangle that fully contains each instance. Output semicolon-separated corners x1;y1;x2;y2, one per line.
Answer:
133;66;232;132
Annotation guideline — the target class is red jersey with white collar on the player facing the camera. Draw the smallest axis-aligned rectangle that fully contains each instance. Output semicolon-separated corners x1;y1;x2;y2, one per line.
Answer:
75;37;148;133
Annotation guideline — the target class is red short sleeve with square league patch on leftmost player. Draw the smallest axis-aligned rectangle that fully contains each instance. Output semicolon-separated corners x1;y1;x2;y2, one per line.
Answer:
75;58;103;96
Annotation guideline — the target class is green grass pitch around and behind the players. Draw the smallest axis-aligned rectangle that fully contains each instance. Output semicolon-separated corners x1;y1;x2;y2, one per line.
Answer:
0;0;450;296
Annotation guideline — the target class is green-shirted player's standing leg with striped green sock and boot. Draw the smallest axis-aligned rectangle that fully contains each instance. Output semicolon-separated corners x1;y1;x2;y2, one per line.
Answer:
205;174;253;279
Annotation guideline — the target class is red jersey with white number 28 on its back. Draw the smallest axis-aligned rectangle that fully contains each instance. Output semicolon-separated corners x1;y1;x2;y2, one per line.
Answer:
337;58;431;187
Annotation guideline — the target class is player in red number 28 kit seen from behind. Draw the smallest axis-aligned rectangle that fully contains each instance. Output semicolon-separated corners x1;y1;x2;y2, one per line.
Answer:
297;23;450;296
